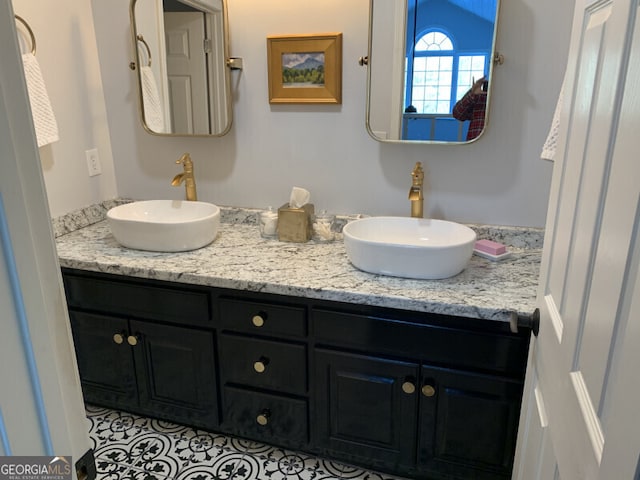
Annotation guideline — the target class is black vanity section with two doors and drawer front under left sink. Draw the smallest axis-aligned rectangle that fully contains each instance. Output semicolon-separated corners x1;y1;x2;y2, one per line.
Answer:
64;274;219;428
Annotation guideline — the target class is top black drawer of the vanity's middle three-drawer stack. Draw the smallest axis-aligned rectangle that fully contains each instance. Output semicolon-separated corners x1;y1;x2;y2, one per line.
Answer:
220;299;307;337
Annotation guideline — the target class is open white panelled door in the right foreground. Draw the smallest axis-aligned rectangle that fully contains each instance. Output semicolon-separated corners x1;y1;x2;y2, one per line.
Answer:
513;0;640;480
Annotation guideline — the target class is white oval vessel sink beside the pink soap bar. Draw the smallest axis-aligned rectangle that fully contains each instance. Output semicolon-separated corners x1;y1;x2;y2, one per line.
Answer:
343;217;476;279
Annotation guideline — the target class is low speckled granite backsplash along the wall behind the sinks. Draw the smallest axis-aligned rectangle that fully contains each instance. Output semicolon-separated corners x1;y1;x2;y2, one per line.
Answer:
52;198;544;249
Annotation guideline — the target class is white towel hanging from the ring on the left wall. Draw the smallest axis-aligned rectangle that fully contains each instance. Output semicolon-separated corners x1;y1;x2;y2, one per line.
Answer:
22;53;60;147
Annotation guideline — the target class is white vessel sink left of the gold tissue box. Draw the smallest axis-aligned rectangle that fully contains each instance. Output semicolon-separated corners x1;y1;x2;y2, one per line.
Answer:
107;200;220;252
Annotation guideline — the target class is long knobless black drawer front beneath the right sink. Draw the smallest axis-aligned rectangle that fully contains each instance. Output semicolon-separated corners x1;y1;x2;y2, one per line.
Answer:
313;309;528;377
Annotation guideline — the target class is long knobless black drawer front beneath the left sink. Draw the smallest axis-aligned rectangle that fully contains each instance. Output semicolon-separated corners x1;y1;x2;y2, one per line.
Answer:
63;274;211;324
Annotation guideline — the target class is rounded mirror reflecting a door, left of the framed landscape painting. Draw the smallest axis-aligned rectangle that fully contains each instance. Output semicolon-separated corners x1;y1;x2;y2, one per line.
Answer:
130;0;232;136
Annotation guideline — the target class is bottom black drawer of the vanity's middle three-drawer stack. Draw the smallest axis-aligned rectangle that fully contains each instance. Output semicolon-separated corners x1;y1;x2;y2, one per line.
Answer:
223;386;309;447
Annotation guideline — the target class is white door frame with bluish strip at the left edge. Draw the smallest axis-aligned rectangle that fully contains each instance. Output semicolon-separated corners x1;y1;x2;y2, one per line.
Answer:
0;1;91;466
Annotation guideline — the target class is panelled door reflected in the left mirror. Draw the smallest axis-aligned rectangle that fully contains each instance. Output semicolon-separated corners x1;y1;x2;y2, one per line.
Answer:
164;12;211;134
